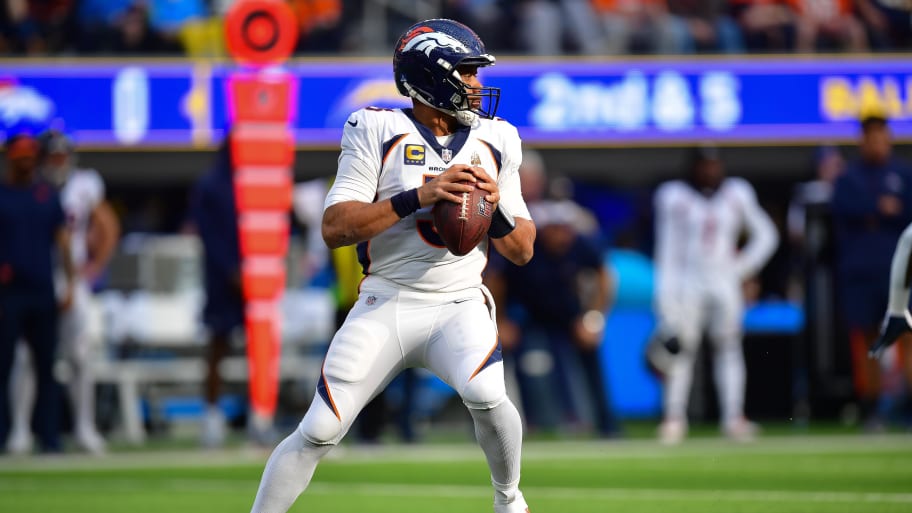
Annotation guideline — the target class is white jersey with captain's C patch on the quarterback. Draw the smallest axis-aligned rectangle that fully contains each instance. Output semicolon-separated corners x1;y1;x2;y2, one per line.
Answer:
324;107;531;292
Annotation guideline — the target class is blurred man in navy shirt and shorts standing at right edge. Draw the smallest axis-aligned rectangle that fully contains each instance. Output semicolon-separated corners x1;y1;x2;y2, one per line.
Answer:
832;113;912;431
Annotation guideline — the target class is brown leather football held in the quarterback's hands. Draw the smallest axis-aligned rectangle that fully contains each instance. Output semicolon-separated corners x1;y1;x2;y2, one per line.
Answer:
431;180;494;256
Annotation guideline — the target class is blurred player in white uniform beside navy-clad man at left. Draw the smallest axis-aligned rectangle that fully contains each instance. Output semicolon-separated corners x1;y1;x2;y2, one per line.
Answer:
8;131;120;453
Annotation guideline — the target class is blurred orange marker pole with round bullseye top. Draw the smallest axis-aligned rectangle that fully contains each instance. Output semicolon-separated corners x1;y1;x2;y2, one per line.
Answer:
225;0;298;429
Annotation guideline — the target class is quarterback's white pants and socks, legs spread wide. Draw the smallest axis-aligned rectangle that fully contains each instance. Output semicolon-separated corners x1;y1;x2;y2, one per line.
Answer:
252;277;526;513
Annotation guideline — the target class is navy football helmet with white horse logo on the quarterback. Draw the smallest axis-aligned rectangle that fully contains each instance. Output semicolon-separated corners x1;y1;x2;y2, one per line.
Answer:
393;19;500;125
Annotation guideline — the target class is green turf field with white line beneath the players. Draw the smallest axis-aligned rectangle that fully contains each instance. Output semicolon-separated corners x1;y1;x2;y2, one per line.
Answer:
0;434;912;513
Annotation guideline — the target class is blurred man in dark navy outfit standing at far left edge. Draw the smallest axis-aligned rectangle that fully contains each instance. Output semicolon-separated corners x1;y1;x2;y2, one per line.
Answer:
0;133;76;452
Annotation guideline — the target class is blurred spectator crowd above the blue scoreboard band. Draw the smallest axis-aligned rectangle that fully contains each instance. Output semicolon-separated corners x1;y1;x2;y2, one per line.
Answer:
0;0;912;56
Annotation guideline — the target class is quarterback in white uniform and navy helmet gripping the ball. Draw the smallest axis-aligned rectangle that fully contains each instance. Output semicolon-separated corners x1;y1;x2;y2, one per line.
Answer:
253;20;535;513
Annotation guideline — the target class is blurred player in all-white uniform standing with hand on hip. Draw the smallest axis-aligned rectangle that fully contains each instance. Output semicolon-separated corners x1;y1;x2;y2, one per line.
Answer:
655;148;778;443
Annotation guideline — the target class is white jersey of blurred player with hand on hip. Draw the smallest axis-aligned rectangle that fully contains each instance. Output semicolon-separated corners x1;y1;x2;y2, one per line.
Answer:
655;178;778;293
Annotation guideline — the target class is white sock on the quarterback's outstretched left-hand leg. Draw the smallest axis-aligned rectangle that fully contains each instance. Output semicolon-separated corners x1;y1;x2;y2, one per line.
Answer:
250;429;335;513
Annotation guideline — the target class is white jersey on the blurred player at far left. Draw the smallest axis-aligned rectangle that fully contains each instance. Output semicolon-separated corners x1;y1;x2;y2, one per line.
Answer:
60;169;105;269
